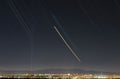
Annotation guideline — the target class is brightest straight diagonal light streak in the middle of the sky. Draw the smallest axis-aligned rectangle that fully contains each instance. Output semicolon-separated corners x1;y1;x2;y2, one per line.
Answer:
54;26;80;62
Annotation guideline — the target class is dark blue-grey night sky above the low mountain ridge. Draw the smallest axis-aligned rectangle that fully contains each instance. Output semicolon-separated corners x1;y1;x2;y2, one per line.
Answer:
0;0;120;72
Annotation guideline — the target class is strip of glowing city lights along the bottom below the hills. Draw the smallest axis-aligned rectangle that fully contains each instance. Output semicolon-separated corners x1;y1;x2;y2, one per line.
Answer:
0;73;120;79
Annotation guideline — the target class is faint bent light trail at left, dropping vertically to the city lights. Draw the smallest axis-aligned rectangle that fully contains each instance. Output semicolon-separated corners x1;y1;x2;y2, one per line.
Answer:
8;0;33;72
